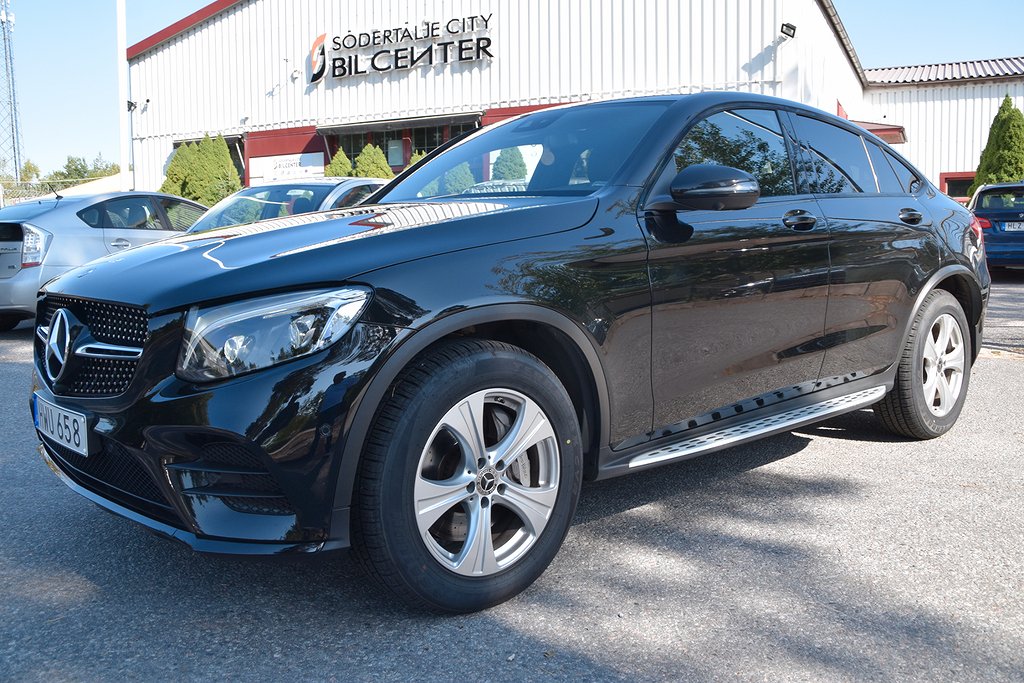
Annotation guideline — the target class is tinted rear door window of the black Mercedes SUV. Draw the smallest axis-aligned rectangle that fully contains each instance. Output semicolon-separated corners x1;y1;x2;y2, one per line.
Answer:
793;115;878;195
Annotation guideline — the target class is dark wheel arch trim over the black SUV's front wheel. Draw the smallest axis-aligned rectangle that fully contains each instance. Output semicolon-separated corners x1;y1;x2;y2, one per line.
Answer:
334;303;608;510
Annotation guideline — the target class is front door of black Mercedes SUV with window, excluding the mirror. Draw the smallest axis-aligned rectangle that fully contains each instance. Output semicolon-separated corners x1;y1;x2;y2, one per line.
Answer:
645;109;828;433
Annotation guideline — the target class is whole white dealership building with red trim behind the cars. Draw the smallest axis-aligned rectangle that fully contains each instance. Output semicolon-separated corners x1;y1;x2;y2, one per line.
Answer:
128;0;1024;200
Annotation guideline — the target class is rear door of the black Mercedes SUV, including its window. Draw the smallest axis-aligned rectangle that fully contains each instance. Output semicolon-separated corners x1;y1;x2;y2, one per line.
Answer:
791;114;941;380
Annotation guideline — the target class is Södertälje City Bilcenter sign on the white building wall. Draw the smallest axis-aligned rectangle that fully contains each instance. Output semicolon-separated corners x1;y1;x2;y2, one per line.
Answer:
309;13;495;83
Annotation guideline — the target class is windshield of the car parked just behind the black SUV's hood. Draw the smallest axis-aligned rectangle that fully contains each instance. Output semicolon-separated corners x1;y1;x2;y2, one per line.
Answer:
188;184;335;232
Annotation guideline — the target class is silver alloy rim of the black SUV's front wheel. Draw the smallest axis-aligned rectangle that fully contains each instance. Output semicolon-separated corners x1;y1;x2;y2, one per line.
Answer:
414;388;560;577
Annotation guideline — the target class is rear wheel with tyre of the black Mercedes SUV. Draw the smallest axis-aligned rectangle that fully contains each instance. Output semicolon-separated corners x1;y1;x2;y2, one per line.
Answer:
874;290;972;439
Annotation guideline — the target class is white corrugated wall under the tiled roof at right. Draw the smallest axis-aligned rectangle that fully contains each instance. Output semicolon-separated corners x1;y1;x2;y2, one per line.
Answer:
865;80;1024;183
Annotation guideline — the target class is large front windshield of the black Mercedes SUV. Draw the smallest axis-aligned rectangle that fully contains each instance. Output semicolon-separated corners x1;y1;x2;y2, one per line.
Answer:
381;100;670;202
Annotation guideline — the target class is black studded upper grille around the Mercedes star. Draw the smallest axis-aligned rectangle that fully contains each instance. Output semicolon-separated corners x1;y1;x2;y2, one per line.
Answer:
36;295;150;398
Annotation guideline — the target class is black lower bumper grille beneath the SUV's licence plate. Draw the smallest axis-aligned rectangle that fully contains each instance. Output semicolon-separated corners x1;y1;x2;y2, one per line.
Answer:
44;439;180;524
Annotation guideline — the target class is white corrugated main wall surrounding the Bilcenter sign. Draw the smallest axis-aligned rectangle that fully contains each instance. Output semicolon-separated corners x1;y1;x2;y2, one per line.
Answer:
130;0;790;187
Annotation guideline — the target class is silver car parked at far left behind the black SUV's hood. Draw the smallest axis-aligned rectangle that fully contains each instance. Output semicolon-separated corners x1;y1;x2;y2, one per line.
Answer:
0;191;206;332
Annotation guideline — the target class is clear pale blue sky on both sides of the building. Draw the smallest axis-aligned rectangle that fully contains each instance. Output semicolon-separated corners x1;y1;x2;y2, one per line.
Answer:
11;0;1024;173
